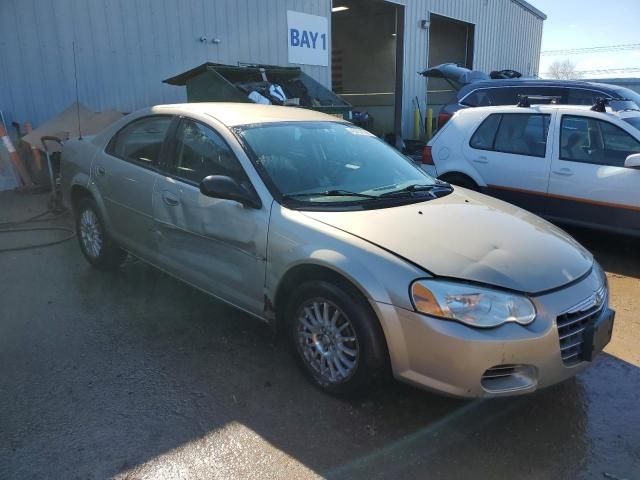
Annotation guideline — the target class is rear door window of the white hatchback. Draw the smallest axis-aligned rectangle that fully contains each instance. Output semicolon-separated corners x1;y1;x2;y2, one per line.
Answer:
469;113;550;157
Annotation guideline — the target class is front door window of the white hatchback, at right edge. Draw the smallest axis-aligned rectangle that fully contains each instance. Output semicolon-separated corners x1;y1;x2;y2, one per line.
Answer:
560;115;640;167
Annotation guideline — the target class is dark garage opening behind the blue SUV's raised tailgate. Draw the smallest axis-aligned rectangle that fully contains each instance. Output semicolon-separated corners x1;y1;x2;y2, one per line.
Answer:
427;13;475;112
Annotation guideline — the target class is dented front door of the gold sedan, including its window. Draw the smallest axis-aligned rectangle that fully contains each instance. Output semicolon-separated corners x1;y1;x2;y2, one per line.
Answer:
153;114;270;315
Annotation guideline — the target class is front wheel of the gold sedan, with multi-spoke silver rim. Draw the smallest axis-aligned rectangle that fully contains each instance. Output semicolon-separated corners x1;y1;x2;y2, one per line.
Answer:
286;280;388;395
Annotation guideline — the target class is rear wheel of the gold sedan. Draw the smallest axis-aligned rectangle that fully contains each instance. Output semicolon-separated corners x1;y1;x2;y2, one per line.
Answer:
75;198;127;270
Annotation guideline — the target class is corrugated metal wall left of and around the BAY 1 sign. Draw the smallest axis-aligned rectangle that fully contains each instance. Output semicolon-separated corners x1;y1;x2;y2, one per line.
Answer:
0;0;331;125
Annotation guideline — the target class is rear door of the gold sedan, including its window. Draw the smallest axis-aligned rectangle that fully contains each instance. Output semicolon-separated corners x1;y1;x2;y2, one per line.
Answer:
92;115;172;257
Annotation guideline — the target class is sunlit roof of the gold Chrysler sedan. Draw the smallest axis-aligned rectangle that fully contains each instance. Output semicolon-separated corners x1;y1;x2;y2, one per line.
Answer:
139;102;344;127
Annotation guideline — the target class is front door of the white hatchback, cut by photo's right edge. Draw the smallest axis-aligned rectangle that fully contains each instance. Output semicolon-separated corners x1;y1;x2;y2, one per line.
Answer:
548;112;640;232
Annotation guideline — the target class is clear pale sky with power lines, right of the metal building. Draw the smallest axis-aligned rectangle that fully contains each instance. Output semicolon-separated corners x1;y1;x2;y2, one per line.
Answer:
528;0;640;78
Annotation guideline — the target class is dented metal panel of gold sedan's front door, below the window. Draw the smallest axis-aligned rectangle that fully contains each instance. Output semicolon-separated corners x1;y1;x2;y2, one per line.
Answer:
153;177;268;314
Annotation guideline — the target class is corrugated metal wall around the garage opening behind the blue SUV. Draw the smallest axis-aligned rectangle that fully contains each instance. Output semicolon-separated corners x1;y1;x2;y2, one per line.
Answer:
402;0;543;137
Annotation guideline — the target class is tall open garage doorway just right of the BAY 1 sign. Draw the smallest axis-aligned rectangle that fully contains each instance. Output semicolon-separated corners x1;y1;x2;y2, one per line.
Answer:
331;0;404;135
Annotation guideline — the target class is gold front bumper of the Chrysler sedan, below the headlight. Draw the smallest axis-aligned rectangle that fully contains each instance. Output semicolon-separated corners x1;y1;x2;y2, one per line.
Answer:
376;266;609;398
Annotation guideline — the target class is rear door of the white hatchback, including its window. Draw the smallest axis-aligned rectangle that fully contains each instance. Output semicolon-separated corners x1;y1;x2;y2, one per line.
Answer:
463;110;551;213
